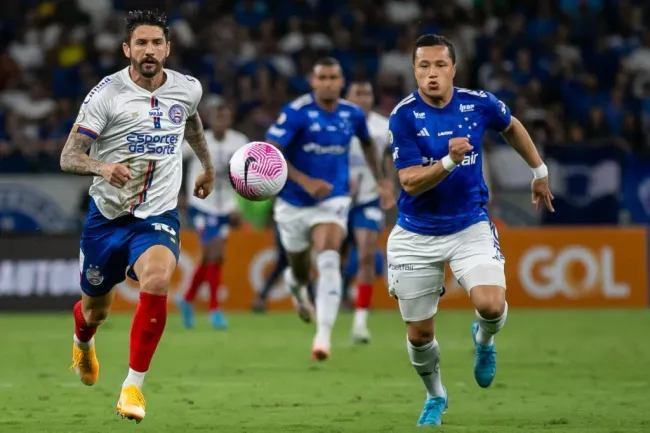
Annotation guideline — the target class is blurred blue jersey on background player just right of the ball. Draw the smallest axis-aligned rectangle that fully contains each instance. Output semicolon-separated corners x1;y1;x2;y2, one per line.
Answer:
266;94;369;207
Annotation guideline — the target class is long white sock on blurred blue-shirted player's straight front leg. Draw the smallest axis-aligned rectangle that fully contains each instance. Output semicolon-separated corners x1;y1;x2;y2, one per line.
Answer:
315;250;343;345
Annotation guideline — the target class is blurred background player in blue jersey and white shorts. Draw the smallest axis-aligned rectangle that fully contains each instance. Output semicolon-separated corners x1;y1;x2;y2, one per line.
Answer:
266;58;387;360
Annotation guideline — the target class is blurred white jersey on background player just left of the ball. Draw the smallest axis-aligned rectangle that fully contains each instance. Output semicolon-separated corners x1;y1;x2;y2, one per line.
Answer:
183;129;248;215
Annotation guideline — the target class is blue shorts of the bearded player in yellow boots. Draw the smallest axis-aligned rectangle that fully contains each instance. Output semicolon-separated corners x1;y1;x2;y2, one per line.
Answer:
79;199;180;296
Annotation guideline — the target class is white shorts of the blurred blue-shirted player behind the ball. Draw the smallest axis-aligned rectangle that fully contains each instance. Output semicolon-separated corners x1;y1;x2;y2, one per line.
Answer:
273;197;352;253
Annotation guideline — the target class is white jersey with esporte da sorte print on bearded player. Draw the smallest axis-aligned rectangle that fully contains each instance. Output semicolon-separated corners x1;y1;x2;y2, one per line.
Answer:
73;67;203;219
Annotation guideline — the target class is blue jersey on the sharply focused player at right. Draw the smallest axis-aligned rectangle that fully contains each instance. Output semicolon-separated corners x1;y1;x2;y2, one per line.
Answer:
389;88;511;236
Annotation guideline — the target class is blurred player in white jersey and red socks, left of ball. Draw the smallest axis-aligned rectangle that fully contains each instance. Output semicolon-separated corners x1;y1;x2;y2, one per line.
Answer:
176;101;249;329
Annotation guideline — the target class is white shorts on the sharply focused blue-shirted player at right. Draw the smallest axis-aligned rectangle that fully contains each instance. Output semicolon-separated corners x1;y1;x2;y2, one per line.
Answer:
387;221;506;322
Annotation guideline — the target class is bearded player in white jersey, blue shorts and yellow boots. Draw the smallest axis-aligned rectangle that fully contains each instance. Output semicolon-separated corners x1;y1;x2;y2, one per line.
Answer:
61;11;215;422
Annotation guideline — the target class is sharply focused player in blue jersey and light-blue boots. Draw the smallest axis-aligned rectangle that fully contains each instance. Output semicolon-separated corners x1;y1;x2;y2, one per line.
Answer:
387;35;553;425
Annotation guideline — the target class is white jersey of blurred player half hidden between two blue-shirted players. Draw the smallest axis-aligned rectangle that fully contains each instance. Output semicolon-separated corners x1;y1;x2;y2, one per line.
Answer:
350;111;388;205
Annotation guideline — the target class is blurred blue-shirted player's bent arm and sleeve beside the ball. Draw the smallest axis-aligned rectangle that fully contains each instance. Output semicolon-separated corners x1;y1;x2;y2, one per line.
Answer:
265;107;332;199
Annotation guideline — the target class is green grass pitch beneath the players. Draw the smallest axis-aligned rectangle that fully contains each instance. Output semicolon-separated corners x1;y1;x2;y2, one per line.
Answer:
0;310;650;433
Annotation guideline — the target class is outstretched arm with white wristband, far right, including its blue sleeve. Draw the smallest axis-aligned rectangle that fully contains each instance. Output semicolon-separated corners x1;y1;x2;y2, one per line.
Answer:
488;94;555;212
